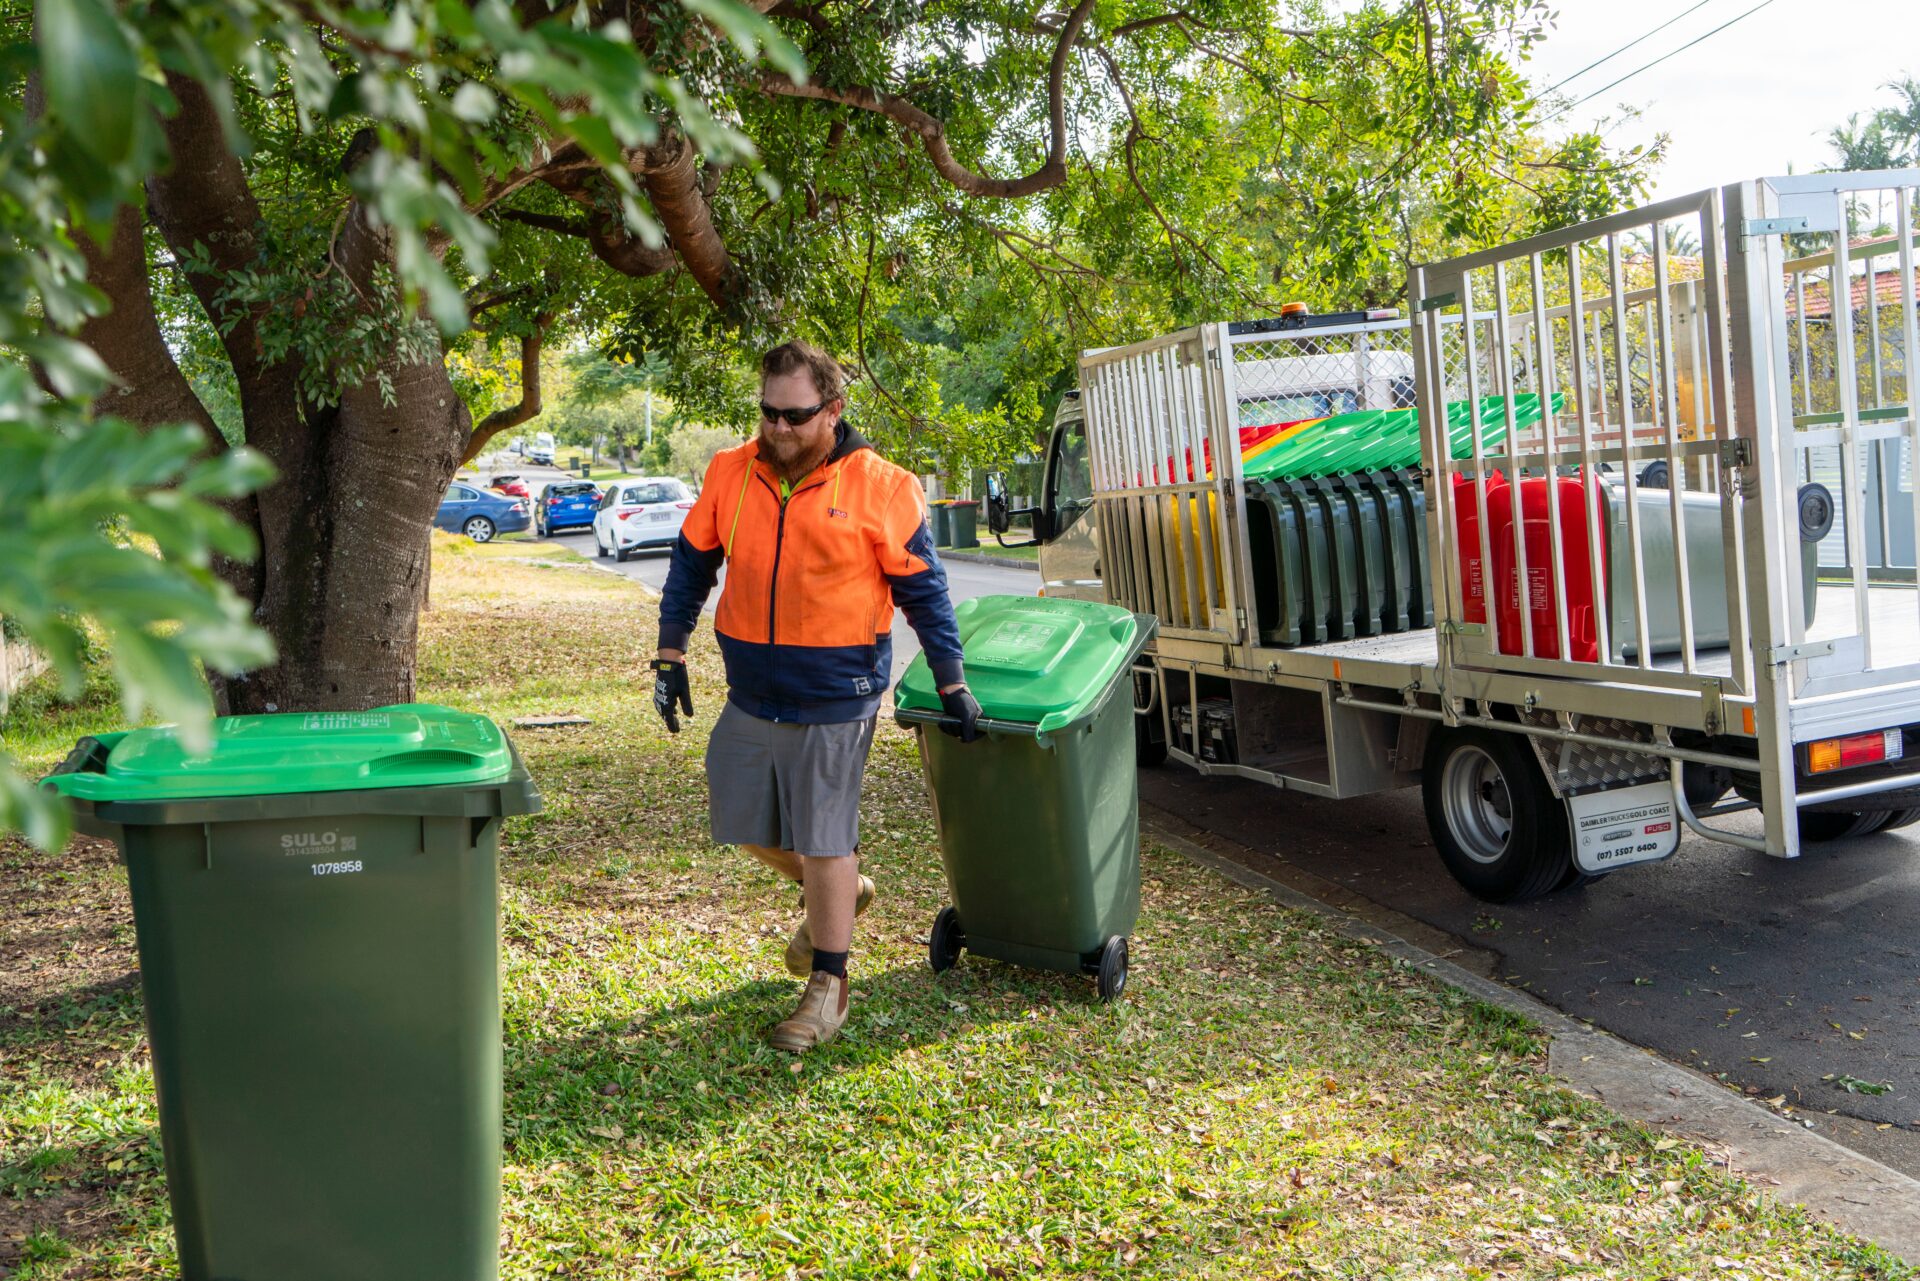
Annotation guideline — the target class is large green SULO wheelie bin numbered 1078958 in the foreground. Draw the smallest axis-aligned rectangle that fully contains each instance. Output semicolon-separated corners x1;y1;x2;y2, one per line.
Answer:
44;705;540;1281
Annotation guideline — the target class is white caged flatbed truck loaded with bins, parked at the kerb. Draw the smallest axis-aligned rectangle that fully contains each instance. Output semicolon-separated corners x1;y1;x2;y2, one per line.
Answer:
987;169;1920;903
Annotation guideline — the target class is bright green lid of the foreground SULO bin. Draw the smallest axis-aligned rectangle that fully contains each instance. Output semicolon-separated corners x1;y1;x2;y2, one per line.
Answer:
46;703;513;801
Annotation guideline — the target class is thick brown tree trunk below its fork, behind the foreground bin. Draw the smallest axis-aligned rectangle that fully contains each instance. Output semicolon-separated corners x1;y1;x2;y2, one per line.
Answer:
215;339;472;714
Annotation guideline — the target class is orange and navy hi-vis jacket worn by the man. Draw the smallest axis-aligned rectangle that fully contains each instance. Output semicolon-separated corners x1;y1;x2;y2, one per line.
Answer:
660;423;960;724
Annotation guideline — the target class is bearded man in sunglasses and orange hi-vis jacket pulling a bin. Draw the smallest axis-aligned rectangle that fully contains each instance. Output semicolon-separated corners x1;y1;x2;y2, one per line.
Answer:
653;342;979;1052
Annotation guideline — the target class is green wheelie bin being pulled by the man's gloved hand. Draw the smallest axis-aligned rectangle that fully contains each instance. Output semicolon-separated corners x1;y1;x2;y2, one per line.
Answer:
895;595;1158;1001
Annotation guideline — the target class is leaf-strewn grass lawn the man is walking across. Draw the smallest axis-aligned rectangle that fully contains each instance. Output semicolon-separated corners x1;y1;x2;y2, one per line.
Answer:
0;542;1912;1281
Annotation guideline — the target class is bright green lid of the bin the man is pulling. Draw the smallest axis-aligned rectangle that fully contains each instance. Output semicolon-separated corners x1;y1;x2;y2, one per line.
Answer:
893;595;1140;734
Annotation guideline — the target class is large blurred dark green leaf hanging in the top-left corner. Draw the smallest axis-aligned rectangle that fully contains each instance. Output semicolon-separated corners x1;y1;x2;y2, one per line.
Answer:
33;0;140;167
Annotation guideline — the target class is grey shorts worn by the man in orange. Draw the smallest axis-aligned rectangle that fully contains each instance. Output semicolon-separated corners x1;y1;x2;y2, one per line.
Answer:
707;703;874;858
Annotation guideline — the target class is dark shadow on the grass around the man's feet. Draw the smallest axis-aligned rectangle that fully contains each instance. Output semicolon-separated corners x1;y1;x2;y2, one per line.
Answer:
507;960;1092;1160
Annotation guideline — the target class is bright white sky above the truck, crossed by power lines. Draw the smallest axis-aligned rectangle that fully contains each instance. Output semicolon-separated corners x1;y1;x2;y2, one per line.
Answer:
1524;0;1920;200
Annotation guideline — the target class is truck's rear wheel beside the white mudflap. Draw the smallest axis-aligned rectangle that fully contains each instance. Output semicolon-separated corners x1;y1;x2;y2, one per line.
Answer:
1421;728;1576;903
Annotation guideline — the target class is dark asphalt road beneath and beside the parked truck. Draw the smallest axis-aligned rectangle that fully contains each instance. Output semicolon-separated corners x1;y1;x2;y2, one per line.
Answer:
1140;764;1920;1177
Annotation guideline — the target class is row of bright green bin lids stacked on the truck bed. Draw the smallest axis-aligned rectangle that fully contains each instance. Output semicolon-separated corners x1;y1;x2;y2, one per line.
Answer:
1244;392;1561;480
